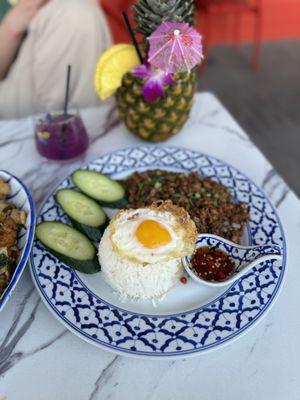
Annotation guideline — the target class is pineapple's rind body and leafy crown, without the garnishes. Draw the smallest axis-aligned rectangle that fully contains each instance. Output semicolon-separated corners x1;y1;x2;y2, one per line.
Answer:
116;0;195;142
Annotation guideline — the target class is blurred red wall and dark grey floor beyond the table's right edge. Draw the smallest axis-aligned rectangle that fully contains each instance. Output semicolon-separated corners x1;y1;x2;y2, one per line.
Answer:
196;0;300;195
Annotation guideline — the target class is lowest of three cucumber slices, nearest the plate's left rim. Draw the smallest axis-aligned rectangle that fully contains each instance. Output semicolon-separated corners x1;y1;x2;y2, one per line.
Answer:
36;222;100;274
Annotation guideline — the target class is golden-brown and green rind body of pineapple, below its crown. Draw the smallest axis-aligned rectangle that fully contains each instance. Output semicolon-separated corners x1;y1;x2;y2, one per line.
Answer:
116;71;196;142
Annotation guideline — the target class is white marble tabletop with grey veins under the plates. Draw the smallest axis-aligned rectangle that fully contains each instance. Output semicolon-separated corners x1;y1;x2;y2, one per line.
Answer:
0;93;300;400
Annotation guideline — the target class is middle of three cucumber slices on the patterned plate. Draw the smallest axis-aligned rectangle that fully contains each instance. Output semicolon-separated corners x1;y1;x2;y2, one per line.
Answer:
55;189;107;242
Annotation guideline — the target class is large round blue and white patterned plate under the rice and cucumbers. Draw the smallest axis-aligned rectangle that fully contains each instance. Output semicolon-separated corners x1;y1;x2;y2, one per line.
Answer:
30;146;286;358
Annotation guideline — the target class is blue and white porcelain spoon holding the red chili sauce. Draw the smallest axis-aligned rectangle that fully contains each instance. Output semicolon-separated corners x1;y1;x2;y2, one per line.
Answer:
182;234;282;287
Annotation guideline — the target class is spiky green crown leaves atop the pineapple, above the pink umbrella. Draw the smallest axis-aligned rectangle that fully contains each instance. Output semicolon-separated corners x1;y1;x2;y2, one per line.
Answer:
133;0;195;36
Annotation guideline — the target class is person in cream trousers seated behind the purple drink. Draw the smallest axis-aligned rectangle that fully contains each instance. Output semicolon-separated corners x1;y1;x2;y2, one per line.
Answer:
0;0;111;118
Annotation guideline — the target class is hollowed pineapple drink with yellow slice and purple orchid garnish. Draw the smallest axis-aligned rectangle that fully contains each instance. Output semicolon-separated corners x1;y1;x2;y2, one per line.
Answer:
95;0;200;142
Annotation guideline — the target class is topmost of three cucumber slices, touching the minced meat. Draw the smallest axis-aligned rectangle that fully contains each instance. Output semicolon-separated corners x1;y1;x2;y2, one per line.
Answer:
72;169;128;208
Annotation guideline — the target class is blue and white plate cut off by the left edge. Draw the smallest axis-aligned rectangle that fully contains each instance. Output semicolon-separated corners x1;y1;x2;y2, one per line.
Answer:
0;171;35;311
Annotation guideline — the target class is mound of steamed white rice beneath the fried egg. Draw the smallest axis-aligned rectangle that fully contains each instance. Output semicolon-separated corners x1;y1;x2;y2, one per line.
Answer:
98;227;182;300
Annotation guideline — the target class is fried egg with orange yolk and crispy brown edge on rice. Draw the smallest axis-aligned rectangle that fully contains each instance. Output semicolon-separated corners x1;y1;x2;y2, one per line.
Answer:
110;201;197;264
